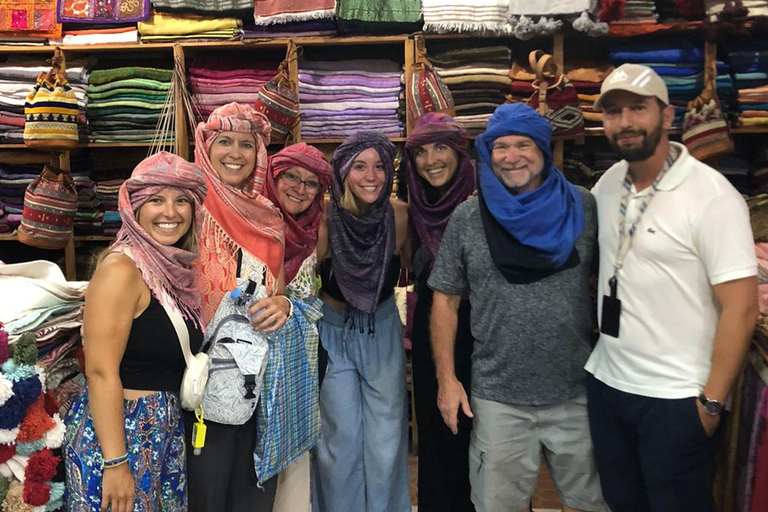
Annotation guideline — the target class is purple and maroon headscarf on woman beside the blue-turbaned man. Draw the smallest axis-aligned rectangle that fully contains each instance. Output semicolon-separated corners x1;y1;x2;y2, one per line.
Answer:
402;112;476;265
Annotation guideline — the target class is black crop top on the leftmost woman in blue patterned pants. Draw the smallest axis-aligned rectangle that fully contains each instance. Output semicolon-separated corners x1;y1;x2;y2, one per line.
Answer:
120;295;203;393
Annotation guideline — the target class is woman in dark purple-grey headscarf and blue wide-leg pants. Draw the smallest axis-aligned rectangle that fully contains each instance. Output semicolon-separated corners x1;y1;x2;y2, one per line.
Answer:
312;132;411;512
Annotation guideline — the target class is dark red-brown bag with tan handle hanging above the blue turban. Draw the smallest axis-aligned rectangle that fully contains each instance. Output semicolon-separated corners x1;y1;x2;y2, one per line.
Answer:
528;50;584;139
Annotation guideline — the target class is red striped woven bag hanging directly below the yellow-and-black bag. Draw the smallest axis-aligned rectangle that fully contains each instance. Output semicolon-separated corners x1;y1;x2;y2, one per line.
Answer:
19;164;77;249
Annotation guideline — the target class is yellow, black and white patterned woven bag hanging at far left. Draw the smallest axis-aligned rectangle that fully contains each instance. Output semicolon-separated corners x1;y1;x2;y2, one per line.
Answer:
24;48;79;150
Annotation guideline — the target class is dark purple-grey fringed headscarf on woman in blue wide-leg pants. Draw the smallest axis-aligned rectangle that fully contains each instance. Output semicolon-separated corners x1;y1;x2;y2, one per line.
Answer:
329;131;395;313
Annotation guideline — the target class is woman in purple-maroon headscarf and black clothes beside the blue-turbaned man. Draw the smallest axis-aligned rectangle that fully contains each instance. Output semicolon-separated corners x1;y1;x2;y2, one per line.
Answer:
400;113;475;512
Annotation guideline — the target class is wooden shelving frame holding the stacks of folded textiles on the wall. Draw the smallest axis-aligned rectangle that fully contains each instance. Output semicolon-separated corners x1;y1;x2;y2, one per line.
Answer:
0;31;768;279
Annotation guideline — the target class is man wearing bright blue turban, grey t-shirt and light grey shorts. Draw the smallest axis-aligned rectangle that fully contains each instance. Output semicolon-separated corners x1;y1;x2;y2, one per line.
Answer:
428;104;607;512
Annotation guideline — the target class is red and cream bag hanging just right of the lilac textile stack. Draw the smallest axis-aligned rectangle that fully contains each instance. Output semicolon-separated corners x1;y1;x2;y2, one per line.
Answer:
406;36;456;123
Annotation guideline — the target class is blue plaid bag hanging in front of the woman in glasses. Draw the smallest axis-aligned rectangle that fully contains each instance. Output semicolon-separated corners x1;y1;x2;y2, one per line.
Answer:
253;298;323;482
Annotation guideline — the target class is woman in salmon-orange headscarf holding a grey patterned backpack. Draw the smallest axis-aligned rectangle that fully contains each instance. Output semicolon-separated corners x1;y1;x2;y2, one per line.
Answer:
186;103;291;512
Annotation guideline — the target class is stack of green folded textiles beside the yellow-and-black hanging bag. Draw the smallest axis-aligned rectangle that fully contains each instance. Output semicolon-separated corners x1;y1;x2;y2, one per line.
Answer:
87;67;173;143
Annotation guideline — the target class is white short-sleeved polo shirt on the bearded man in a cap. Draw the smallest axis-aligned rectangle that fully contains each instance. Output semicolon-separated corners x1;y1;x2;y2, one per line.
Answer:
585;142;757;398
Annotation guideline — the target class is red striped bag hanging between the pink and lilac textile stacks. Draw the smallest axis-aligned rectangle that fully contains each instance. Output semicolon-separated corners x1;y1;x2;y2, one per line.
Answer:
254;40;299;142
